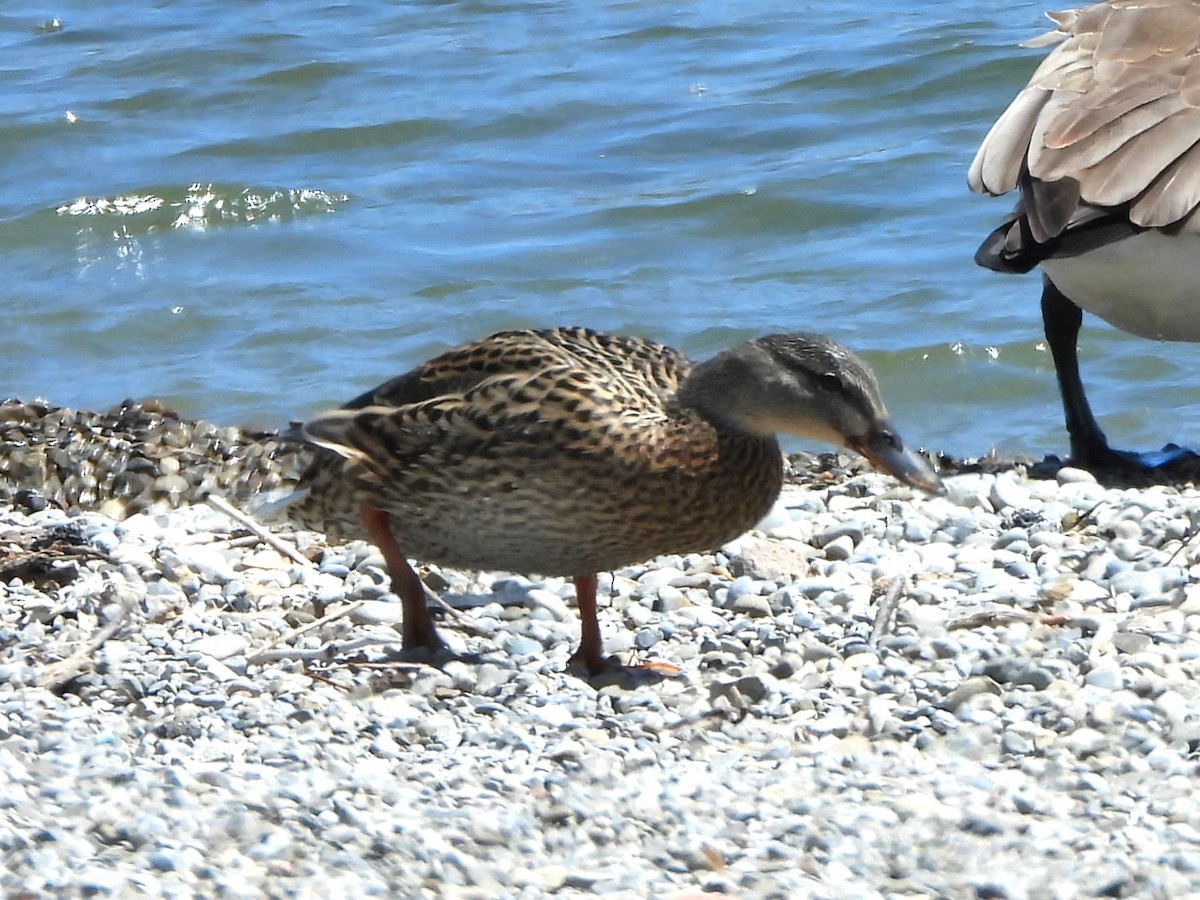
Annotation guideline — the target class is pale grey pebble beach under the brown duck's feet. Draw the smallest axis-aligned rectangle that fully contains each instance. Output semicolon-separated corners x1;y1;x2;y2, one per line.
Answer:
0;402;1200;900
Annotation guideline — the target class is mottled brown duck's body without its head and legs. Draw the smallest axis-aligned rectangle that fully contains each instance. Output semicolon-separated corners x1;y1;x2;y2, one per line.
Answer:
285;329;782;575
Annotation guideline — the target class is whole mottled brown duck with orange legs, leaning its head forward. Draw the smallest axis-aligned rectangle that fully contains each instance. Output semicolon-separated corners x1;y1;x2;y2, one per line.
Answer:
285;329;941;673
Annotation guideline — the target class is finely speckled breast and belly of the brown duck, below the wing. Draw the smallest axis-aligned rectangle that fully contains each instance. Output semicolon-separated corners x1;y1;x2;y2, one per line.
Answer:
372;424;782;575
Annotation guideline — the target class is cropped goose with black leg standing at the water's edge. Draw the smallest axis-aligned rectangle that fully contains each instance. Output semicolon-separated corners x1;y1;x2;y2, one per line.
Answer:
967;0;1200;474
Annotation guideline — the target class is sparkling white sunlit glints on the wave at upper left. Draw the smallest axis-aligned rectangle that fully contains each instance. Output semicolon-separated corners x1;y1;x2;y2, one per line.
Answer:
55;184;349;232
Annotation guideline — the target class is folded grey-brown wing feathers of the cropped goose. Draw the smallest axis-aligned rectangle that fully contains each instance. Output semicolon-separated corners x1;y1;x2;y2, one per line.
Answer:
967;0;1200;242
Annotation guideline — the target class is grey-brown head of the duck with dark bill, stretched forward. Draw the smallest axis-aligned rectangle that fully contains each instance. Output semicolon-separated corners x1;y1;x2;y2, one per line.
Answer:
680;334;944;493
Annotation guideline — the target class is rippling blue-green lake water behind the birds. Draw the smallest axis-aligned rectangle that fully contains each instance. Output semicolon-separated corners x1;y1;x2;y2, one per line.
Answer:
0;0;1200;455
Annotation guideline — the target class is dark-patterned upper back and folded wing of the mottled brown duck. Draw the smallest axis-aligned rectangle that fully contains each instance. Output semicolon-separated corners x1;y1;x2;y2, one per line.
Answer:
301;329;710;480
